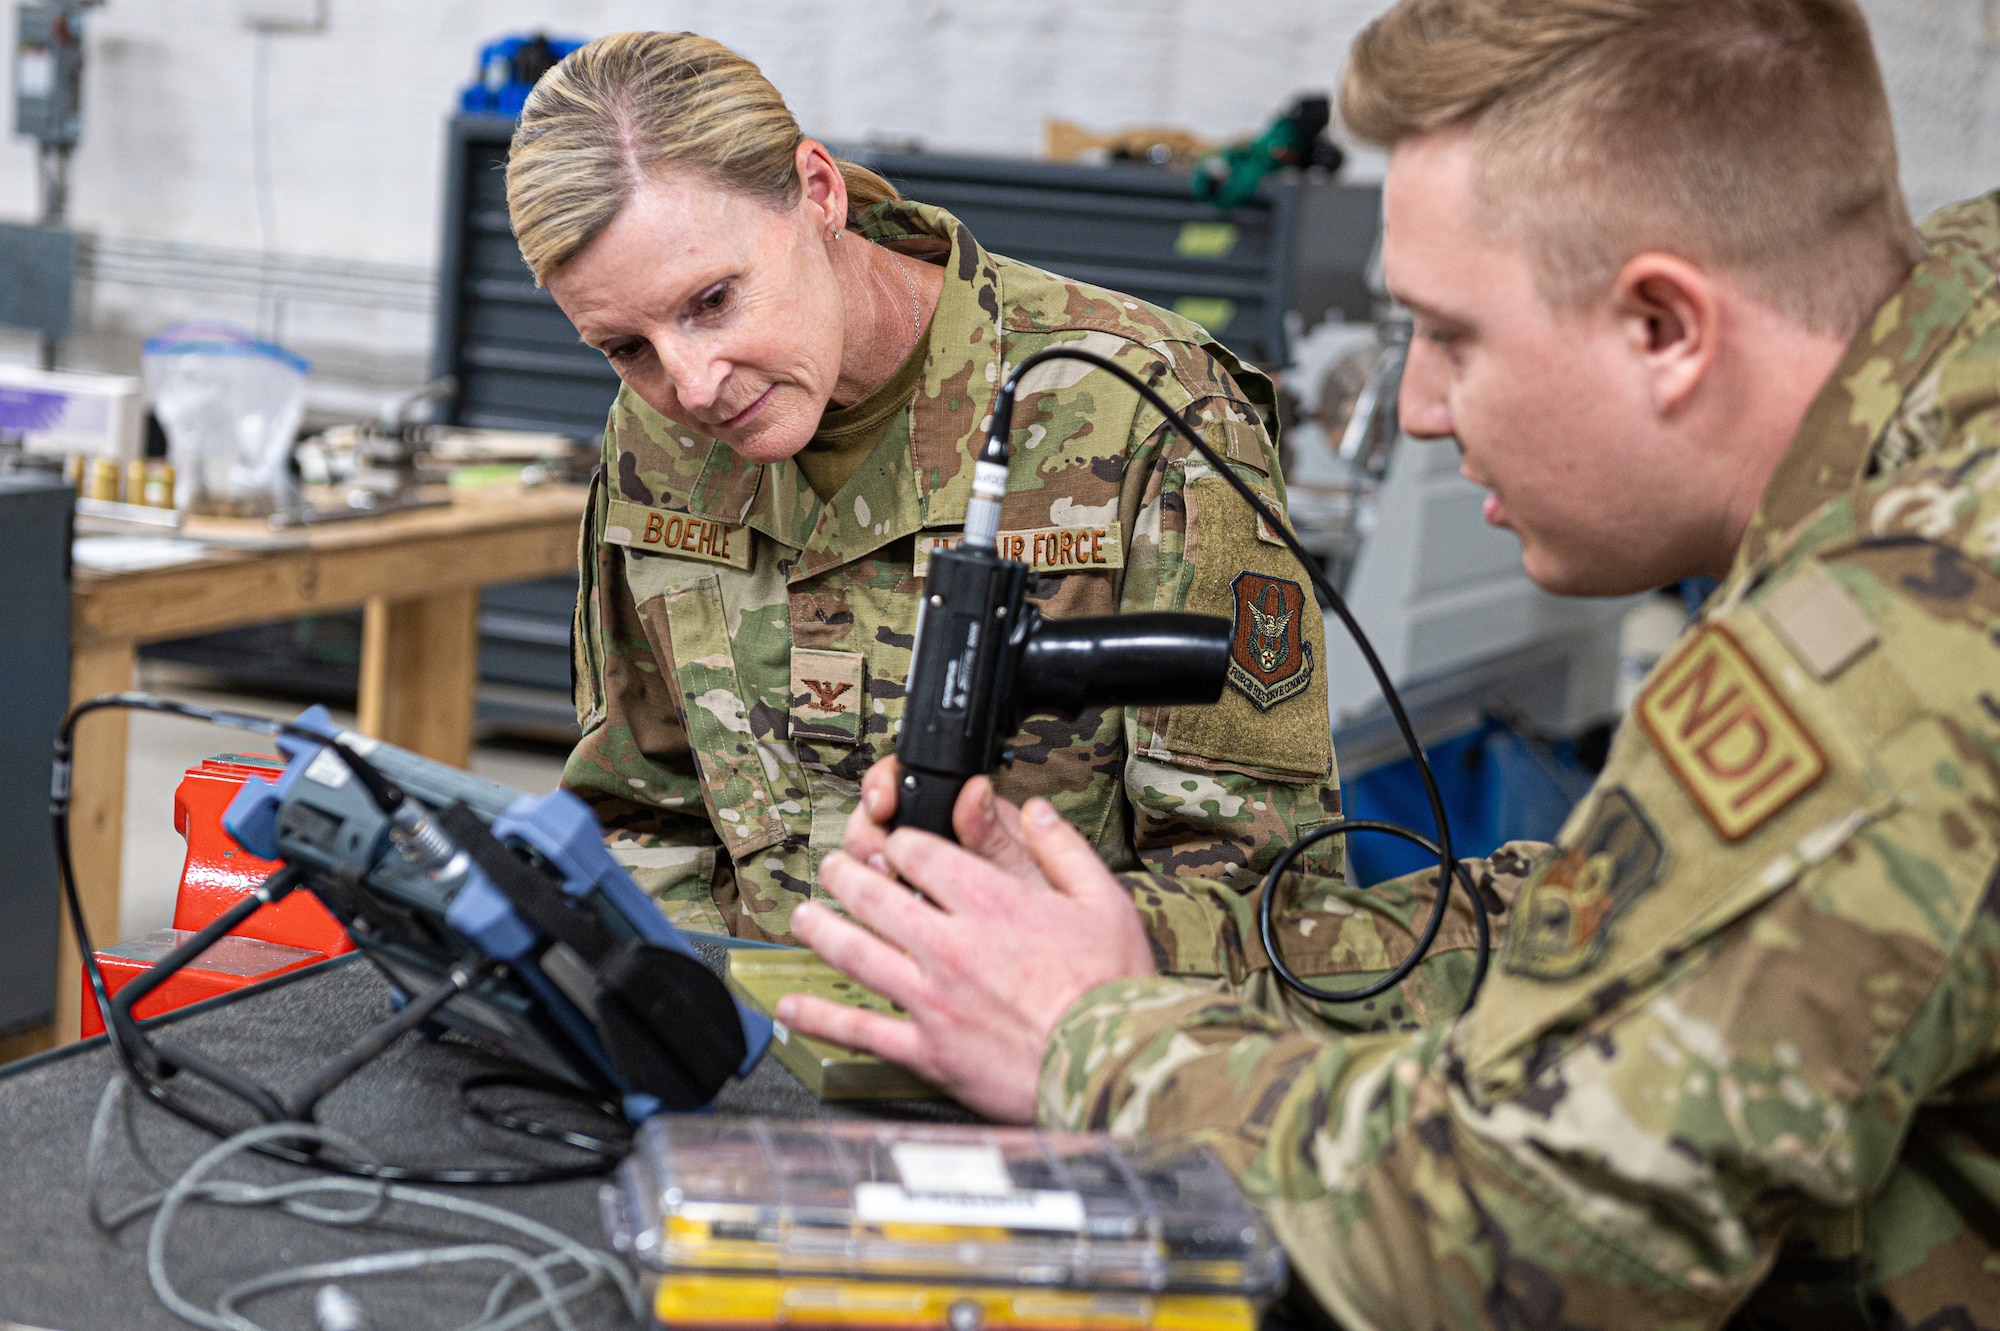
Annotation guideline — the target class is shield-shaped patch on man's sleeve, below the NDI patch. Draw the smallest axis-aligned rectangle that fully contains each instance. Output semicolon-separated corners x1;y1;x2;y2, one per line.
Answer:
1502;785;1666;981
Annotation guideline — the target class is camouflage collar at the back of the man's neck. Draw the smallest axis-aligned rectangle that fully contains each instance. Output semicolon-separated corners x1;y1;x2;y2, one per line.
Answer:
1736;194;2000;572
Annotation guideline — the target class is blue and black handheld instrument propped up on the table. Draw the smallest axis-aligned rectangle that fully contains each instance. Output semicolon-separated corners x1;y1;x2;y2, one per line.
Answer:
222;707;770;1121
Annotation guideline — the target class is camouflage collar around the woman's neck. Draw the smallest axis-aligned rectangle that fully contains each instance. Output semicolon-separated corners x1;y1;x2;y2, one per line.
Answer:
690;202;1002;582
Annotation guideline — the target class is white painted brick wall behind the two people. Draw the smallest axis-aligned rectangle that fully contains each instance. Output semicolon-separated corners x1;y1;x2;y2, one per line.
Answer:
0;0;2000;393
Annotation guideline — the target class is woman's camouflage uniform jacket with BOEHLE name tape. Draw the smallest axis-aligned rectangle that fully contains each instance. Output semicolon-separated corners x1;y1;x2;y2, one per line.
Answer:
564;204;1340;943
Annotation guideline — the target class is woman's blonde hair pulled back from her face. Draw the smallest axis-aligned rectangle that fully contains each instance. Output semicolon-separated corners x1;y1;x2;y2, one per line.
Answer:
506;32;898;284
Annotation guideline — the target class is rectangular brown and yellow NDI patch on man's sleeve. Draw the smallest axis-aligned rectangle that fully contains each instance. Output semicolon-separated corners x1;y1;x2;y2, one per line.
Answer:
1638;624;1826;841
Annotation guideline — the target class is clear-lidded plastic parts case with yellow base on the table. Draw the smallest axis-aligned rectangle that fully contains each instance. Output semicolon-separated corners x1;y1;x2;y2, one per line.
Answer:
602;1115;1284;1331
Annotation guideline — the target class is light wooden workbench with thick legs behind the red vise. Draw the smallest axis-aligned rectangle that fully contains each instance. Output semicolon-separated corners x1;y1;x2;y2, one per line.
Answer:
21;486;586;1059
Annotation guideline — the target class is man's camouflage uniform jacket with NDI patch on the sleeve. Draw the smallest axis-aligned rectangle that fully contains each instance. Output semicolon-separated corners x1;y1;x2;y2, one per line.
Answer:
1040;196;2000;1329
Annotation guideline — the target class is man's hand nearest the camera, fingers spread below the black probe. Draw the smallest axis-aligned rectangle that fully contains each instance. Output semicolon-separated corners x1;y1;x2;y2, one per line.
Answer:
778;765;1154;1123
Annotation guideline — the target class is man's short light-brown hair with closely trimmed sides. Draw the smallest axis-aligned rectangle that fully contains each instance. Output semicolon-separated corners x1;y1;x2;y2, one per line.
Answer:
1340;0;1924;336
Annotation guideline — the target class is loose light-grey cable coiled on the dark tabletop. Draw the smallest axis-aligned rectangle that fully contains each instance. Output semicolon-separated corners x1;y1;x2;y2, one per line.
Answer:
84;1077;642;1331
